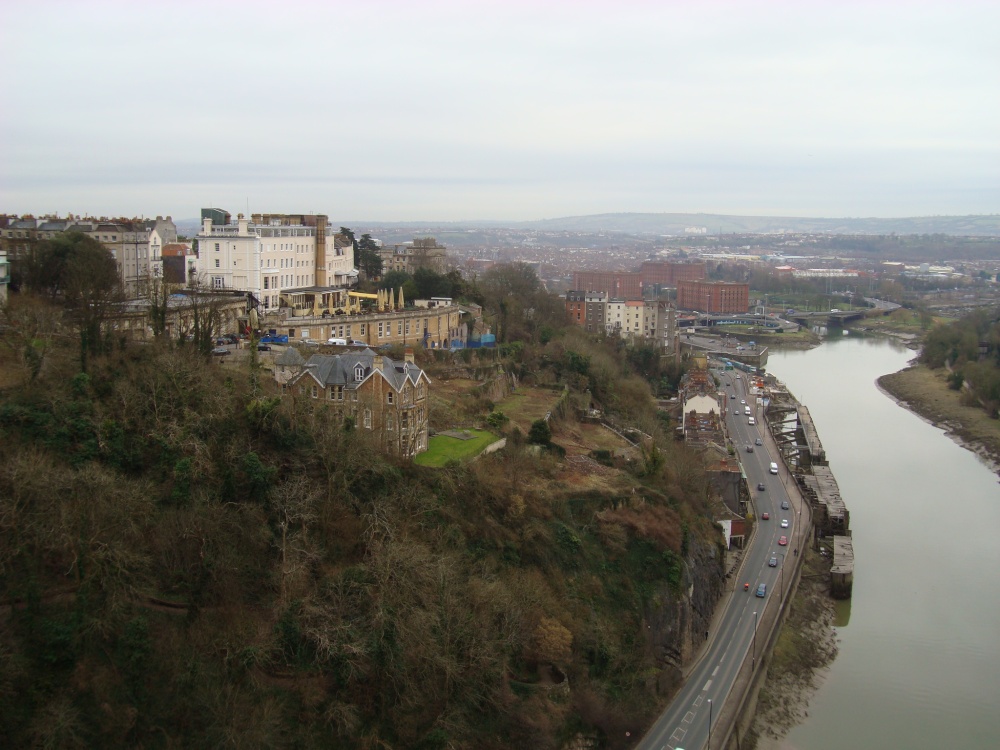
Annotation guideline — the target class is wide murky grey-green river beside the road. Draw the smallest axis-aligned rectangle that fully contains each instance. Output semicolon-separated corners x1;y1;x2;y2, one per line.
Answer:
767;335;1000;750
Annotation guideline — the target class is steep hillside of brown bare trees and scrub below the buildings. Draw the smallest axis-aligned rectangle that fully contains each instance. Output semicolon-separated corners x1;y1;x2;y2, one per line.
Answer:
0;294;723;749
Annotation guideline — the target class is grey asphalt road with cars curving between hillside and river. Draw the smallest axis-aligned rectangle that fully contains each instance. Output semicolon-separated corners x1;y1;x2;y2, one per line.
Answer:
636;371;798;750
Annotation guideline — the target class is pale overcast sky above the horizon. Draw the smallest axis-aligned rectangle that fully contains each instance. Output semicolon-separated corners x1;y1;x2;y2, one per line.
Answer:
0;0;1000;222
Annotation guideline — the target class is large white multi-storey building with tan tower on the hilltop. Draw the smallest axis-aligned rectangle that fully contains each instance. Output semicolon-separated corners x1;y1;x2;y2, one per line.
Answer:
196;209;357;312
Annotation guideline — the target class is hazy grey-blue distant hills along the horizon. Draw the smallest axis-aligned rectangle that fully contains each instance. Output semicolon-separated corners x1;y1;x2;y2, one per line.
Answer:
176;213;1000;237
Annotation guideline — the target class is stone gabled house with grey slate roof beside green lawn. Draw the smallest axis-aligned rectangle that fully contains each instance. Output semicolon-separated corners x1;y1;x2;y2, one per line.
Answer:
282;349;431;457
